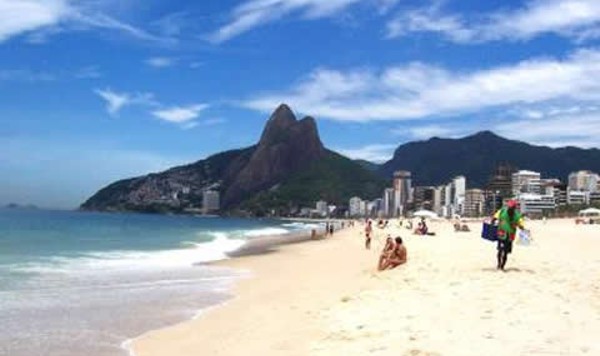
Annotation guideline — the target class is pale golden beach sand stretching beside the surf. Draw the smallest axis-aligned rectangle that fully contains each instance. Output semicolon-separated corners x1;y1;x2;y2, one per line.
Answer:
132;220;600;356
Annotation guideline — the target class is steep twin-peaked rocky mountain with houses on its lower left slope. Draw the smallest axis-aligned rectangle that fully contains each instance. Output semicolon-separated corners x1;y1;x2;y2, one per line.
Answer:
81;104;385;215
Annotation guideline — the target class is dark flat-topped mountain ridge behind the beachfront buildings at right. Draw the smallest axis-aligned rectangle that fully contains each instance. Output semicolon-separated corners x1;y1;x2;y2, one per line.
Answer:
379;131;600;187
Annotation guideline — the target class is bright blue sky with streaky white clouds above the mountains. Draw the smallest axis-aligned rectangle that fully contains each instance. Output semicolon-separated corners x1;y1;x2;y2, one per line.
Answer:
0;0;600;208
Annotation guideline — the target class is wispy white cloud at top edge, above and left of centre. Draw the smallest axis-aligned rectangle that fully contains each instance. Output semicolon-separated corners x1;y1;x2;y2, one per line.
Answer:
208;0;364;43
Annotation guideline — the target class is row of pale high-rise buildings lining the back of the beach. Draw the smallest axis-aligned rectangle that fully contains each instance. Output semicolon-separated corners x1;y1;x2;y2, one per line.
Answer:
348;168;600;218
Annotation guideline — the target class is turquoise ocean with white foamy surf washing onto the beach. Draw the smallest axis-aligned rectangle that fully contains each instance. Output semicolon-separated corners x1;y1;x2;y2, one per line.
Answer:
0;209;317;356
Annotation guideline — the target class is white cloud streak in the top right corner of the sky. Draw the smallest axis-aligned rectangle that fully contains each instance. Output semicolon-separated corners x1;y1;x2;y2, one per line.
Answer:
387;0;600;43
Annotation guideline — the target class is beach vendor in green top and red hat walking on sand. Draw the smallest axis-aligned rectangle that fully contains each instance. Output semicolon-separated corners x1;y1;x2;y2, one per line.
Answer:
492;200;525;270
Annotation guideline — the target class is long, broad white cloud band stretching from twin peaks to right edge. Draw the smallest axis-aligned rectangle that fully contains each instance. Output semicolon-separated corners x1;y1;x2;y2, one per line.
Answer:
241;49;600;121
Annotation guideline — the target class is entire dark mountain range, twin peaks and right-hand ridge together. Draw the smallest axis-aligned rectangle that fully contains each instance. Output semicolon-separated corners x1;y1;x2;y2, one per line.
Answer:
81;104;600;215
